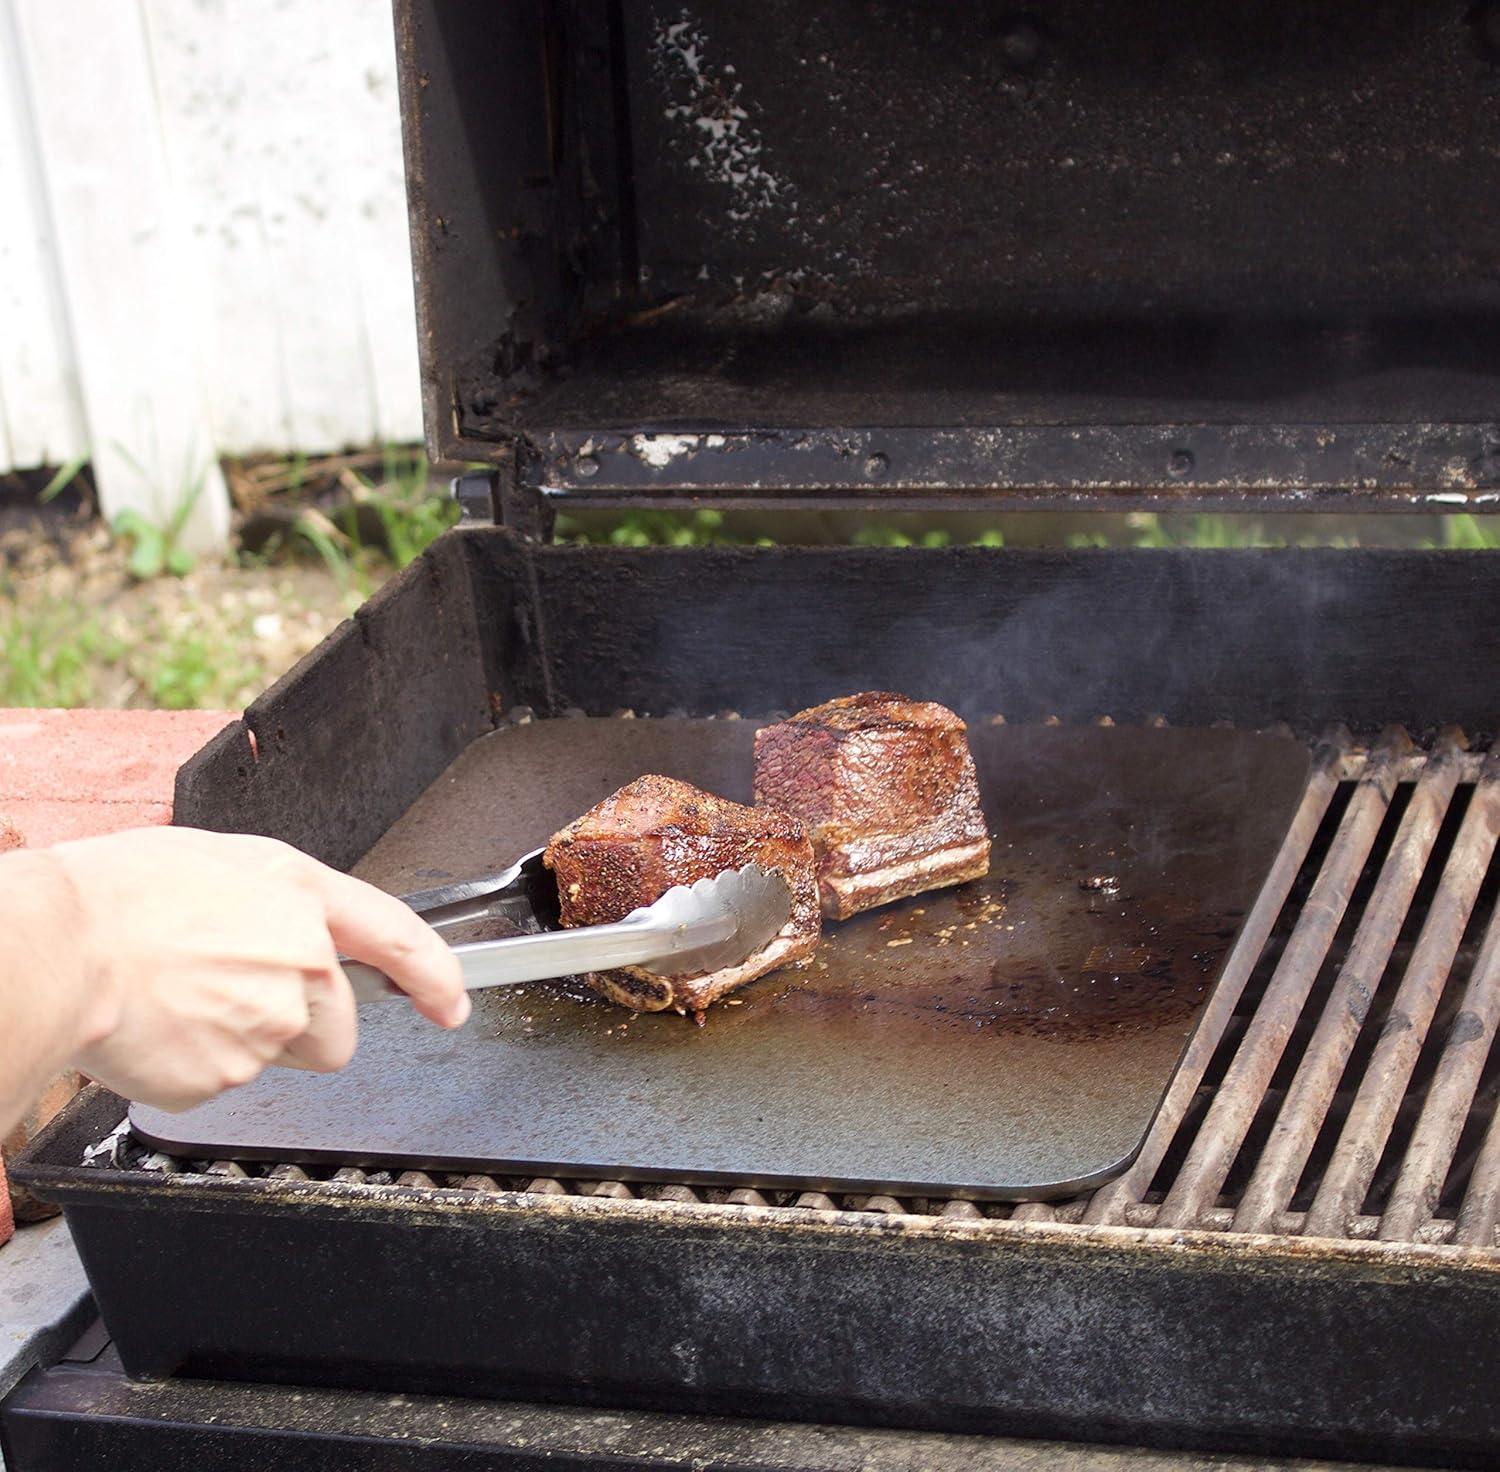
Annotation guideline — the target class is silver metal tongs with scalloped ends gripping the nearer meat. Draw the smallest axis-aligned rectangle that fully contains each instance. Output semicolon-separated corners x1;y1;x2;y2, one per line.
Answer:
344;849;792;1002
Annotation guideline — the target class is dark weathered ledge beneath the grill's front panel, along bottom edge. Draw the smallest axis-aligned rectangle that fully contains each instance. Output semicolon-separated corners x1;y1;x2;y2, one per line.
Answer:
3;1337;1434;1472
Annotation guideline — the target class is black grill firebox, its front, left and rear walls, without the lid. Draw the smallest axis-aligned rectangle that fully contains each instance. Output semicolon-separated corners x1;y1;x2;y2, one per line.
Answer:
8;530;1500;1466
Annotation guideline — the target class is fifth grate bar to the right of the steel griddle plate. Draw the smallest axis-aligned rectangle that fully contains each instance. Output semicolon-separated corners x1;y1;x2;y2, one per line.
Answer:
1380;888;1500;1242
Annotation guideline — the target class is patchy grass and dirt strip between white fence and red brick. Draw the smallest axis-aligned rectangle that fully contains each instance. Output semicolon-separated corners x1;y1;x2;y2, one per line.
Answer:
0;447;458;710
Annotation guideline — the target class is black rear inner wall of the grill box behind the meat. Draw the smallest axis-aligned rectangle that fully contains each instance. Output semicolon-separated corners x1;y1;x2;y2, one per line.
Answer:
473;534;1500;735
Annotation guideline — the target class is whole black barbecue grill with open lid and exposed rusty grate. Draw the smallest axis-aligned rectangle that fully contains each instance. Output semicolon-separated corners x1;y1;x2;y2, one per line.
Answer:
3;0;1500;1472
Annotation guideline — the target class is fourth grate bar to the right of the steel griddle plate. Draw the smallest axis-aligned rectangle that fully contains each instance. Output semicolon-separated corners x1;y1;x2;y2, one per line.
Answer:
1305;750;1500;1236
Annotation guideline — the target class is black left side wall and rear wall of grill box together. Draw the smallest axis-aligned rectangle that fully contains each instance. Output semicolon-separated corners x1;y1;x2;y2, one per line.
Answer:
177;528;1500;866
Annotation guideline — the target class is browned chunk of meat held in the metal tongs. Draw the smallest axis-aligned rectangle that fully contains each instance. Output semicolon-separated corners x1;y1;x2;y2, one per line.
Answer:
543;776;822;1014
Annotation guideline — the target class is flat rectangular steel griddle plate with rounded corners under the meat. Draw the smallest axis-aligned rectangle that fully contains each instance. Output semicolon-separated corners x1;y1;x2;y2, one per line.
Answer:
131;720;1308;1197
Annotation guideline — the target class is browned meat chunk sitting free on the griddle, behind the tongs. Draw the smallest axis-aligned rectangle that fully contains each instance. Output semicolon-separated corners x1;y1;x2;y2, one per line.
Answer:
755;690;990;920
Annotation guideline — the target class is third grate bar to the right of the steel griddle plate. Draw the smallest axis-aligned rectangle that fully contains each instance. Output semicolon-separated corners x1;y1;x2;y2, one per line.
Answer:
1233;732;1463;1232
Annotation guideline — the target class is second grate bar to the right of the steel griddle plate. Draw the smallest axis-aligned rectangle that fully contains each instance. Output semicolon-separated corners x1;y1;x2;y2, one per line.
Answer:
1157;729;1410;1227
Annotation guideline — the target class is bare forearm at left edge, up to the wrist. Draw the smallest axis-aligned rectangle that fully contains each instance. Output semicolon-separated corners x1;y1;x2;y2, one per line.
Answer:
0;849;108;1136
